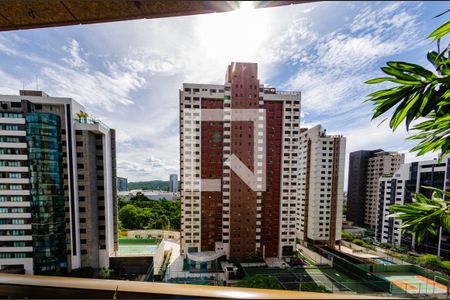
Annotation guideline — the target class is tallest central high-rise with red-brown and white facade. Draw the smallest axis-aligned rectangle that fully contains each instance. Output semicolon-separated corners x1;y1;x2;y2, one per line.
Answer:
180;63;300;268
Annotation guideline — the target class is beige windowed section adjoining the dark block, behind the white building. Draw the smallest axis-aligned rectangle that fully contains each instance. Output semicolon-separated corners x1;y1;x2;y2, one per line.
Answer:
364;151;405;228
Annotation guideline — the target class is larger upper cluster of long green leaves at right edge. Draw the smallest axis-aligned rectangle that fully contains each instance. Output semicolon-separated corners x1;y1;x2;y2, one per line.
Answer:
366;11;450;155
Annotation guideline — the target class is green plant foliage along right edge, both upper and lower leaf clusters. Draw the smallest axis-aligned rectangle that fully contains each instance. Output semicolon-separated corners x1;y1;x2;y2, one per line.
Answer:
366;14;450;242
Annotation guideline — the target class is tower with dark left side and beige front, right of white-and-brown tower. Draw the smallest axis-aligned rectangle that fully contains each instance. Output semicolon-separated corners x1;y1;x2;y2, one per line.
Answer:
347;149;405;228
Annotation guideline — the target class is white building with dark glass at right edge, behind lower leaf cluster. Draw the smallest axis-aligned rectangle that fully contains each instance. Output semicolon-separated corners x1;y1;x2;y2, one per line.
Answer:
377;155;450;259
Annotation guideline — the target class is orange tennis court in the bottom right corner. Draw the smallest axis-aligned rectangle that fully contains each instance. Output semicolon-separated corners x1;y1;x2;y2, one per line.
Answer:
377;272;447;294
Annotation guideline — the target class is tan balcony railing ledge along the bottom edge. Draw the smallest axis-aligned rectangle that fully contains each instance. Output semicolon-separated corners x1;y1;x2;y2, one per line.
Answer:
0;274;382;299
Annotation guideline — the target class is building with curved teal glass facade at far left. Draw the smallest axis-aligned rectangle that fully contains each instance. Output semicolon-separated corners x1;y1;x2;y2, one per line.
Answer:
0;91;117;274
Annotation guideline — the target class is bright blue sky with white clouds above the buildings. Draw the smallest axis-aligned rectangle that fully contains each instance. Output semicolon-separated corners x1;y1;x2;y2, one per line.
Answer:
0;1;449;186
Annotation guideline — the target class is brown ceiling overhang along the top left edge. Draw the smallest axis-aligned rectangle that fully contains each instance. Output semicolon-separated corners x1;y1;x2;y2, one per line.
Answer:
0;0;311;31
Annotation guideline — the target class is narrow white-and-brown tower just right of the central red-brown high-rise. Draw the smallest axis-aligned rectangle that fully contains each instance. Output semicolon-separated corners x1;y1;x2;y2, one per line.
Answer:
297;125;346;246
